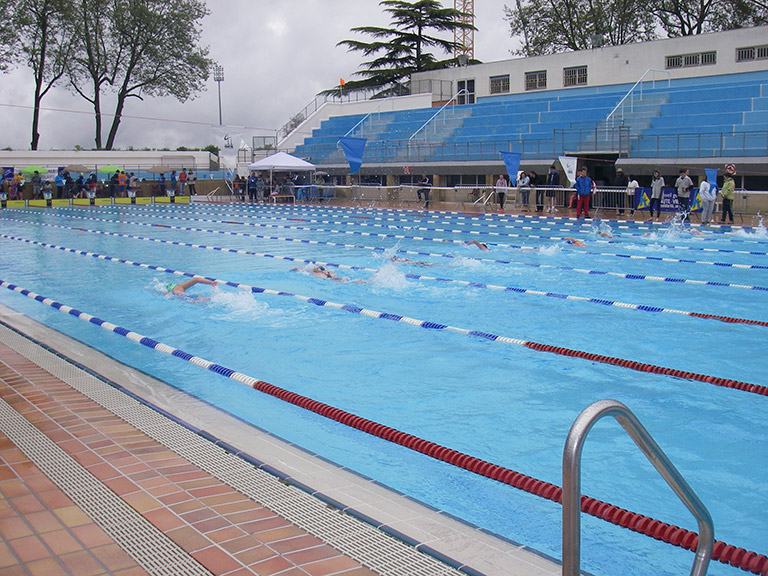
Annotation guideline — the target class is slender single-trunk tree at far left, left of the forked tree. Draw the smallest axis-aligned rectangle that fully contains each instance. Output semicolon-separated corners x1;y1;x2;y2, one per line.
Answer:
11;0;71;150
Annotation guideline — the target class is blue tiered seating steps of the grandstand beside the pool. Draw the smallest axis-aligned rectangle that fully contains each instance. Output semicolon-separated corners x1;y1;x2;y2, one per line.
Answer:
295;72;768;165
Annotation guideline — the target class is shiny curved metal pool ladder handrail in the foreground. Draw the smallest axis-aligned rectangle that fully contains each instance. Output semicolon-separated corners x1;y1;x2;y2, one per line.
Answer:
563;400;715;576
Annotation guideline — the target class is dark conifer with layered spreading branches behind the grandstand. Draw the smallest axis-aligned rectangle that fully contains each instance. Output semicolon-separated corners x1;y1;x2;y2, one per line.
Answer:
334;0;475;97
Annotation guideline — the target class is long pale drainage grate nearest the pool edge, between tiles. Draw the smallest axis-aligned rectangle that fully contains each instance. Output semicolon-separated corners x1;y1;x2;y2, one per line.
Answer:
0;325;468;576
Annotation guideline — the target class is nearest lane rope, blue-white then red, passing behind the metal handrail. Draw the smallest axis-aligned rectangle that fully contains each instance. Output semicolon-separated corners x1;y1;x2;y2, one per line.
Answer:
0;279;768;574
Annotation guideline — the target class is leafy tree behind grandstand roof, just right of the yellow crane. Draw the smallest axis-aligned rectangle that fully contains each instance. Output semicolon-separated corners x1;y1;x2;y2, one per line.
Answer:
504;0;655;56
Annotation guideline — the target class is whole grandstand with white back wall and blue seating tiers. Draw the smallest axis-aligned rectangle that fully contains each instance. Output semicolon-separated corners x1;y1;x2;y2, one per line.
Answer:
279;27;768;190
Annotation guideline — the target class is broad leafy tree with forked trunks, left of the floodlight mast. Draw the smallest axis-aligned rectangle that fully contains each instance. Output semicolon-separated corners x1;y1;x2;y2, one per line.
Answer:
69;0;212;150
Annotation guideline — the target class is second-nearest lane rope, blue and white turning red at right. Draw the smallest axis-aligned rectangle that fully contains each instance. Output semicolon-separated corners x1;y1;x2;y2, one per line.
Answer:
3;232;768;396
